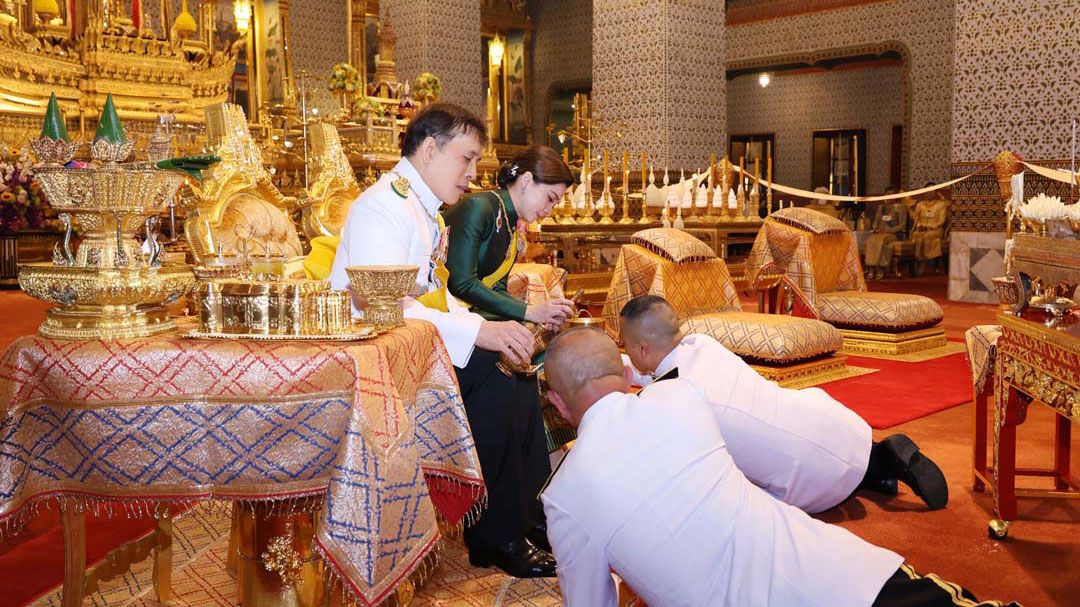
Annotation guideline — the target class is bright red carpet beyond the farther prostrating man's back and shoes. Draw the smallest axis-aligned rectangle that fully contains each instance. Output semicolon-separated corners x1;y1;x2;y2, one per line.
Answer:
820;352;972;430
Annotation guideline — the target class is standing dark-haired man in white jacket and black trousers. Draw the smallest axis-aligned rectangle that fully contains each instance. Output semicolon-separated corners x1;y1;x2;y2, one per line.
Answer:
330;104;555;577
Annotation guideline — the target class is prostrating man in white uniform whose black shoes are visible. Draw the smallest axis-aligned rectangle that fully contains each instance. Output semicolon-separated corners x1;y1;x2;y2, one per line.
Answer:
620;295;948;513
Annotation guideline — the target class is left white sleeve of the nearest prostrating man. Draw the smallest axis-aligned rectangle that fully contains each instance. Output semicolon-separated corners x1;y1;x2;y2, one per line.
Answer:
542;497;619;607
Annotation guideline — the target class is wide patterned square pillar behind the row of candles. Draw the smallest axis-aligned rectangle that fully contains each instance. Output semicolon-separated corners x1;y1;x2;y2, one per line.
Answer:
593;0;727;168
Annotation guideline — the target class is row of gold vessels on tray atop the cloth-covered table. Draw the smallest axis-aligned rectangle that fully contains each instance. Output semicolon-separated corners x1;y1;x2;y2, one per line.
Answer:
190;279;375;340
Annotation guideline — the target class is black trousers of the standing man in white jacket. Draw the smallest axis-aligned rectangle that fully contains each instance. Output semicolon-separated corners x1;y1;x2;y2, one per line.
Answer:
455;348;551;547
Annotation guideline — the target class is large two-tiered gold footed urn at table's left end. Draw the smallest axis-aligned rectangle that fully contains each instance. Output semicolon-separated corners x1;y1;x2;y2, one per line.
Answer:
18;162;194;339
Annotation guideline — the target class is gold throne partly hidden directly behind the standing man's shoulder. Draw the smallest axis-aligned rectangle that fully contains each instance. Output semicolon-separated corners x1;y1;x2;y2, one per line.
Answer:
300;122;361;240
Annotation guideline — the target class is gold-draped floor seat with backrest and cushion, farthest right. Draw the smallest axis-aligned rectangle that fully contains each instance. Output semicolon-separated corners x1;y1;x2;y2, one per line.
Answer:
746;207;946;354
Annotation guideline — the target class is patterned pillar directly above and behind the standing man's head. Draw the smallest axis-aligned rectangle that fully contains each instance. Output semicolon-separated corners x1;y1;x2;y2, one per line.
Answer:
383;0;484;117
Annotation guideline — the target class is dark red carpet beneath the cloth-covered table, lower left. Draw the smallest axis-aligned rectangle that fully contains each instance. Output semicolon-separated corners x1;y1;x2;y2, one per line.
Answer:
0;507;154;607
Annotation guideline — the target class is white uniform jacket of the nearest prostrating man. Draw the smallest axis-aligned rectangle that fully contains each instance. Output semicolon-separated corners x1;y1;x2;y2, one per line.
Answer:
542;379;903;607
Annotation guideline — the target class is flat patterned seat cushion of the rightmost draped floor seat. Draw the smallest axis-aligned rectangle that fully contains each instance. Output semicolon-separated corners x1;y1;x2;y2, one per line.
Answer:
818;291;942;333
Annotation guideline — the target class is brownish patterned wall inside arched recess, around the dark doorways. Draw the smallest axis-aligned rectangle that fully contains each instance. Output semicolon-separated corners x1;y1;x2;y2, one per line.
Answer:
728;66;904;193
